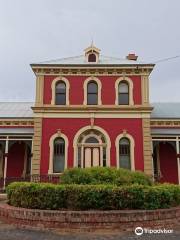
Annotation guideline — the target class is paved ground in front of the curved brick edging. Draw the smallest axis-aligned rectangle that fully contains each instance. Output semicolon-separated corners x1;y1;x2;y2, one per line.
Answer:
0;222;180;240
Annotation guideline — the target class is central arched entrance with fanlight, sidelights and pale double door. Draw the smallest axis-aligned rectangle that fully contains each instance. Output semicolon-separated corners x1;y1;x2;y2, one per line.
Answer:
77;129;107;168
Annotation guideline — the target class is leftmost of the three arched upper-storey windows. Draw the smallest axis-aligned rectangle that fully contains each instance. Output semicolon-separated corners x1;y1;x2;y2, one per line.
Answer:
55;81;66;105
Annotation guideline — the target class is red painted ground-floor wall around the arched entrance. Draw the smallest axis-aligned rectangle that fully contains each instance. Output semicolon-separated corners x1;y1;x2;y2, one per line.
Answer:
41;118;144;174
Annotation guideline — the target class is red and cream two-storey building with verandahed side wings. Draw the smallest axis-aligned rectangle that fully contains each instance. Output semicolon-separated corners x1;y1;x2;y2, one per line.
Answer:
0;45;180;188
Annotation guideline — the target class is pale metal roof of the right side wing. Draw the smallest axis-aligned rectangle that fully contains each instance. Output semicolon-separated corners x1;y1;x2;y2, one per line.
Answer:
151;102;180;119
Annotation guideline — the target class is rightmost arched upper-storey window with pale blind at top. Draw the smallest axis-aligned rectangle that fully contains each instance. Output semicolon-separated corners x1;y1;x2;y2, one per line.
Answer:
118;81;129;105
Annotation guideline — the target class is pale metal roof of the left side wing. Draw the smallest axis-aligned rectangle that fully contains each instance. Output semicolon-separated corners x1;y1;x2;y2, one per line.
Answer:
0;102;34;119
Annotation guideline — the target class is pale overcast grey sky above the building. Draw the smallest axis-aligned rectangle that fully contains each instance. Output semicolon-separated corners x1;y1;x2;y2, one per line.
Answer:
0;0;180;102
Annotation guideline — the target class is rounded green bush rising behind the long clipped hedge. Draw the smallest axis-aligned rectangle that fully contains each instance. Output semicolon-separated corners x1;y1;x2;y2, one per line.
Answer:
61;167;152;186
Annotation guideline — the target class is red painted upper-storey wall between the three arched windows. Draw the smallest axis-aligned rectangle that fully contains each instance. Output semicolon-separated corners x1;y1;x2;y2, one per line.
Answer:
43;76;142;105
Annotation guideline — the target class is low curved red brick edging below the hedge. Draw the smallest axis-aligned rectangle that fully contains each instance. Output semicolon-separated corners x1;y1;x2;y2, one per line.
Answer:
0;203;180;232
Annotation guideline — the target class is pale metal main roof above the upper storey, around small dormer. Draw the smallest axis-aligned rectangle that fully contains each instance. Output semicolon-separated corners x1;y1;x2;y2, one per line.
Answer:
31;54;154;66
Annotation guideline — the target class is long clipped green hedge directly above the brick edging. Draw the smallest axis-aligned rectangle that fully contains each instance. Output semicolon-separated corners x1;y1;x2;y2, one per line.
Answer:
7;183;180;210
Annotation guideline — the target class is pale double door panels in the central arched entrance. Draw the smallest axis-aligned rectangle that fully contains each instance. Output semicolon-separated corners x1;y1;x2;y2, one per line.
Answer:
83;147;100;168
